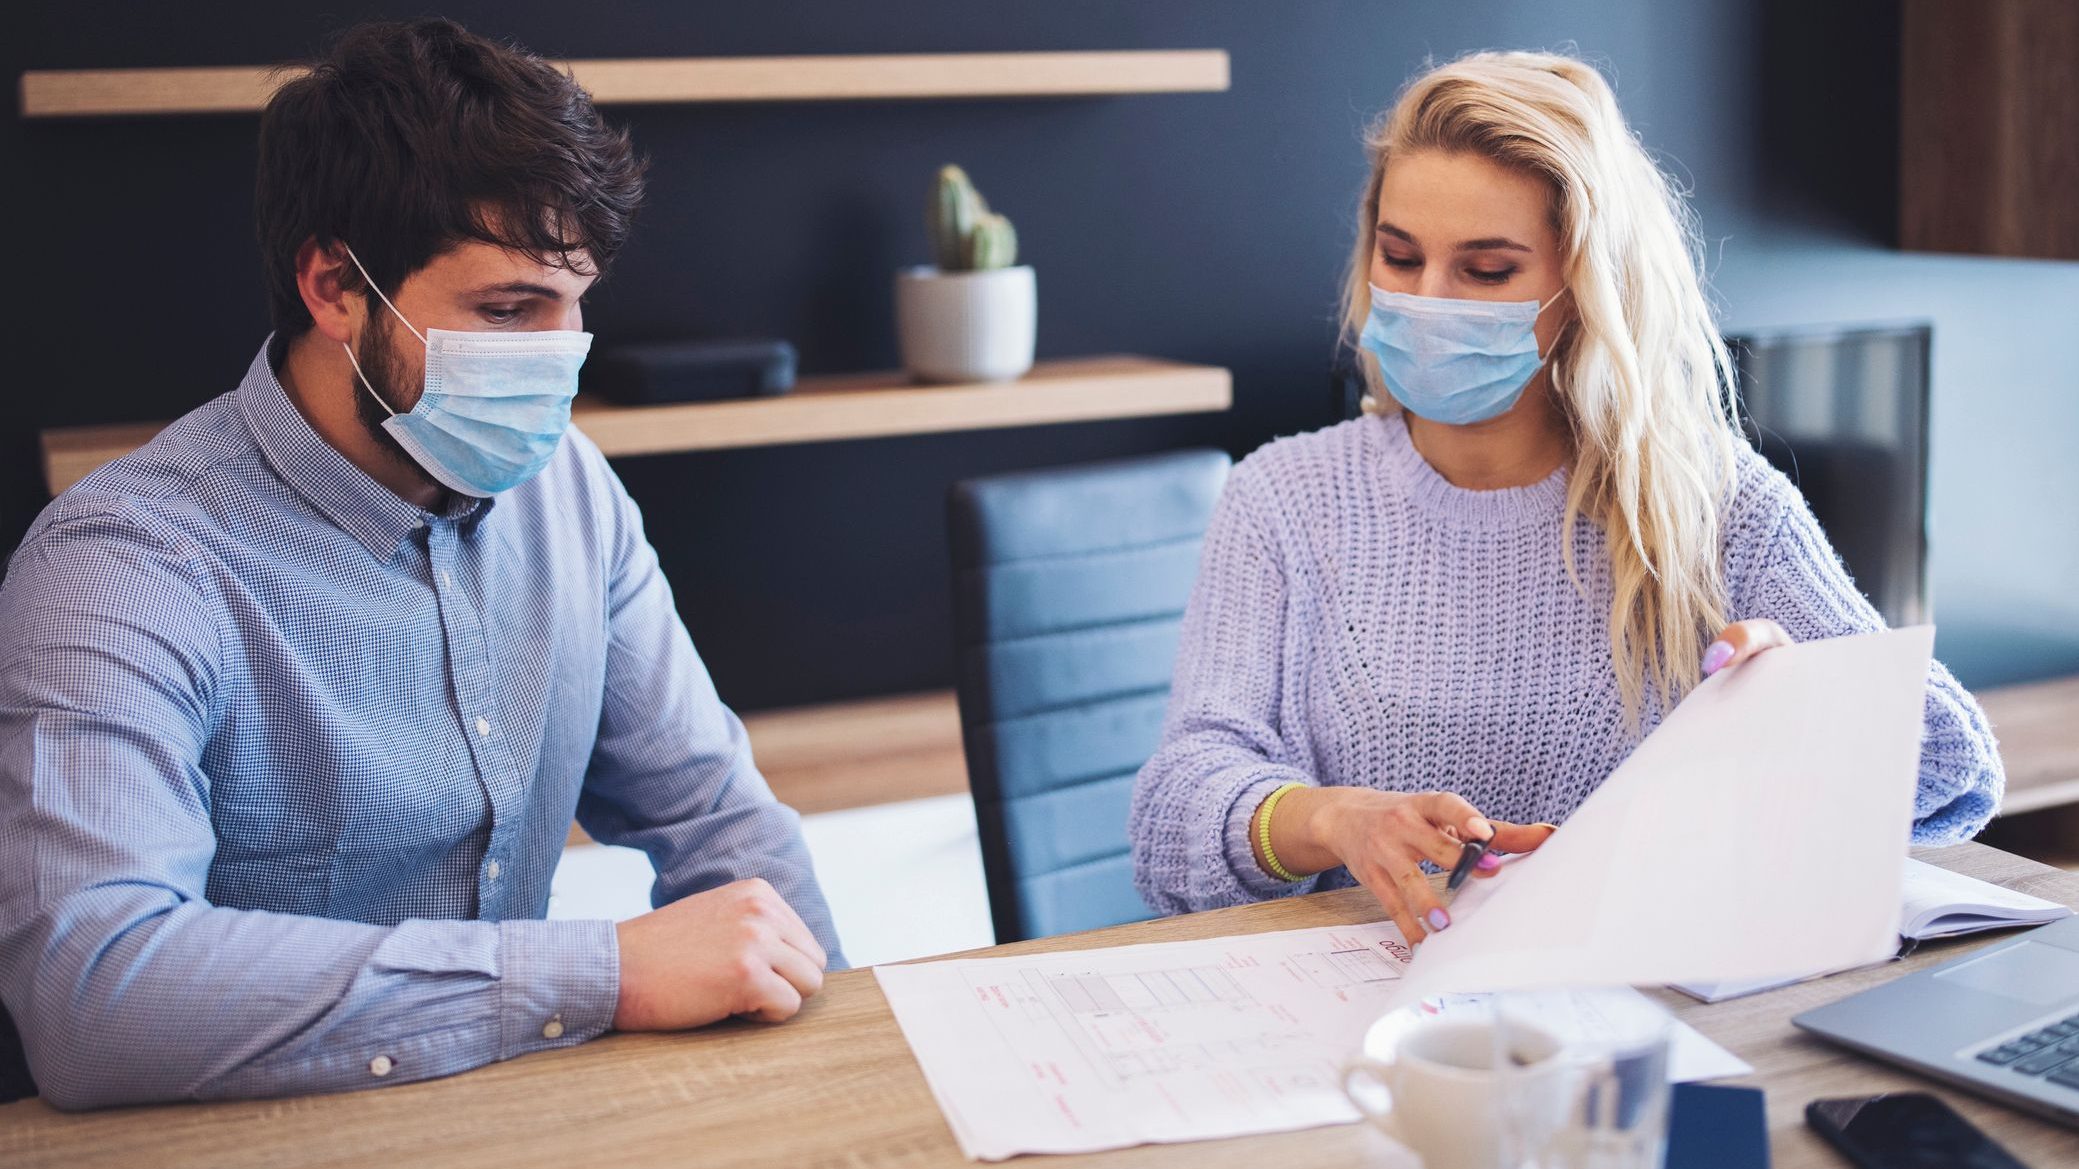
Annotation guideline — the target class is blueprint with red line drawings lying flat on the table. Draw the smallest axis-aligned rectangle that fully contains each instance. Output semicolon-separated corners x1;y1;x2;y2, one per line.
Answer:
873;921;1748;1161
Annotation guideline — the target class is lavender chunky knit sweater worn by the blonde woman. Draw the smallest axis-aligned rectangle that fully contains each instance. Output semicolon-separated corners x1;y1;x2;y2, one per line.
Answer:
1129;416;2004;913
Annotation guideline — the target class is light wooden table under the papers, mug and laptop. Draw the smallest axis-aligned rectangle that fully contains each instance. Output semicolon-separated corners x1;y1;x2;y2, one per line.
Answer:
0;845;2079;1169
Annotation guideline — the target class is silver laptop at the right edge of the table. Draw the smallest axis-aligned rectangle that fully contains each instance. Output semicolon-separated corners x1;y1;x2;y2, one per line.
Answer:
1792;917;2079;1127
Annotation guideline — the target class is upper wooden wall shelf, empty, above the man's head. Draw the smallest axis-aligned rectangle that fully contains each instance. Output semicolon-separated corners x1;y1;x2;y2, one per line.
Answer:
21;48;1227;119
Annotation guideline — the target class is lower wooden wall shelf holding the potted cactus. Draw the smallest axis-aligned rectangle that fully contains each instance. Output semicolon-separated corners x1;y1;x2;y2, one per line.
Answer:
44;356;1233;495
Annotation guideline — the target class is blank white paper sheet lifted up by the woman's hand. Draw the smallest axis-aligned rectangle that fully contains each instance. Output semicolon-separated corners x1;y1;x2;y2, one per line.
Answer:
1389;626;1933;1005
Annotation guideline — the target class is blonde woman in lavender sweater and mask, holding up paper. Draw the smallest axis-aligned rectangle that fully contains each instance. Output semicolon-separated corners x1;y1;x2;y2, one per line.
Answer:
1131;52;2002;940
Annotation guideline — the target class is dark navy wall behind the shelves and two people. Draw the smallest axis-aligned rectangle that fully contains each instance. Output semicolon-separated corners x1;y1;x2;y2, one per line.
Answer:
0;0;2079;707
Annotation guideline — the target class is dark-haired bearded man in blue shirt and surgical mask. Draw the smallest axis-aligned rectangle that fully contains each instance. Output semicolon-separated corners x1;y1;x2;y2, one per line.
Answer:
0;21;842;1109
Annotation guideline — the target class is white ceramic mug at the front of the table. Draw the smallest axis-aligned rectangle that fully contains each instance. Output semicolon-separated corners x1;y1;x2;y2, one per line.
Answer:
1343;1011;1563;1169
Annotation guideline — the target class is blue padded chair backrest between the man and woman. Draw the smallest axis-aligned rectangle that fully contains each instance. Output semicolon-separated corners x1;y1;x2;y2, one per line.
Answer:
948;451;1229;942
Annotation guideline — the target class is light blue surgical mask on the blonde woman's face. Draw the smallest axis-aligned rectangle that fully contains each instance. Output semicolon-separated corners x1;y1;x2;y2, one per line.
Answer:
1358;285;1563;426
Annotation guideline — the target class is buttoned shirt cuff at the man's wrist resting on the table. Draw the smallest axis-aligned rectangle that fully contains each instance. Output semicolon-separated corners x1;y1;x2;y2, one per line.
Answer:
499;921;622;1059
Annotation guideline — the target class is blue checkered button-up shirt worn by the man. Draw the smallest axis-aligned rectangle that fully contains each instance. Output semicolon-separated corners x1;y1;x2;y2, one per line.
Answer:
0;334;842;1107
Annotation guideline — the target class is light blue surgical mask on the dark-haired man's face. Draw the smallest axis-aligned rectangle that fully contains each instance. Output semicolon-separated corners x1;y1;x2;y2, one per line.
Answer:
343;248;593;497
